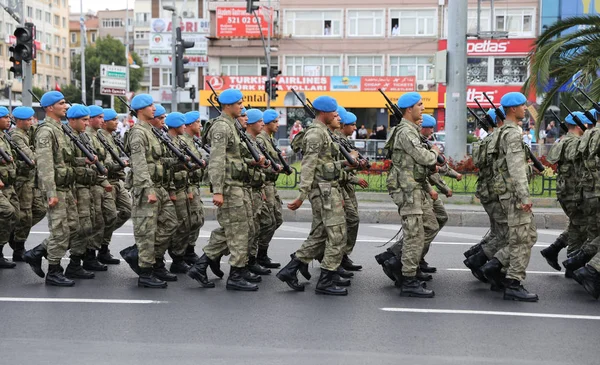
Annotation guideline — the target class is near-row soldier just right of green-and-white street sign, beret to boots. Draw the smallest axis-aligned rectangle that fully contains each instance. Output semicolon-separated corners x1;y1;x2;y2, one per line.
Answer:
121;94;179;288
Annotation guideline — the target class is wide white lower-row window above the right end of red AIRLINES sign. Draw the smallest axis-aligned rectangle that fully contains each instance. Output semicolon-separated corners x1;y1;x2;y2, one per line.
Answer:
285;56;342;76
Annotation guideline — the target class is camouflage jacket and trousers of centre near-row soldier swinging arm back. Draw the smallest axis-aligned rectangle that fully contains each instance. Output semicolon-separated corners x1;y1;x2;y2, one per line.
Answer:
296;119;346;271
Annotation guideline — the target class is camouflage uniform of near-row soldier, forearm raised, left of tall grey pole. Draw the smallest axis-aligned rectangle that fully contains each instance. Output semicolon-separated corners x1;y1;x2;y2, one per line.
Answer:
387;119;439;277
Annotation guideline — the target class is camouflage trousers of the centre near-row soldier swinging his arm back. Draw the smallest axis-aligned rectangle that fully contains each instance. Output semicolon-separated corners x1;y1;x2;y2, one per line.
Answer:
296;182;346;271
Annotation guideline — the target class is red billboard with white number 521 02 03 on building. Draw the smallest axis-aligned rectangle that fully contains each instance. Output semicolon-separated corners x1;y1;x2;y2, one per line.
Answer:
216;7;273;38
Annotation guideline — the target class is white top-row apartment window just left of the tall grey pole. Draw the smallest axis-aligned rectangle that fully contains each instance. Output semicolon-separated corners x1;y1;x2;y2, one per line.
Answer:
390;9;436;36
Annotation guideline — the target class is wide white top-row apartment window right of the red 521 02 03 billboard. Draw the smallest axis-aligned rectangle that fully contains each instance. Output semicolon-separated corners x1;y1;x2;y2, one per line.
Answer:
285;10;342;37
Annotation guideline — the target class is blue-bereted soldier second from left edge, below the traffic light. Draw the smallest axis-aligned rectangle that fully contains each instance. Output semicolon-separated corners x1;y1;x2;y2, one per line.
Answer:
9;106;47;261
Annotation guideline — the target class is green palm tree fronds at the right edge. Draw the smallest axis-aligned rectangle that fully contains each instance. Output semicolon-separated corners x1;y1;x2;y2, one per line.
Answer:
523;15;600;130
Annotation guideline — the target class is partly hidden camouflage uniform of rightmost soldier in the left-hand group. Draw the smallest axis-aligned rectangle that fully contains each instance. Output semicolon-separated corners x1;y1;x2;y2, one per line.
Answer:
98;129;131;246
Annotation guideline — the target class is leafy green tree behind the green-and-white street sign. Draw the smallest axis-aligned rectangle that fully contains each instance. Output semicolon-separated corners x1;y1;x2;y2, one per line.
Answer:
70;36;144;106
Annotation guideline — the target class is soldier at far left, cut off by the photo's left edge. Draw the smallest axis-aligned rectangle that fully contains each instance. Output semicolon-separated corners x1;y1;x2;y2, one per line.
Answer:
0;106;20;269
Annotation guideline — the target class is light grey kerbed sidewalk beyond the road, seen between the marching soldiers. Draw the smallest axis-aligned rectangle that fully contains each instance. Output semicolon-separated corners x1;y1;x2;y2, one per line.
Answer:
202;189;568;229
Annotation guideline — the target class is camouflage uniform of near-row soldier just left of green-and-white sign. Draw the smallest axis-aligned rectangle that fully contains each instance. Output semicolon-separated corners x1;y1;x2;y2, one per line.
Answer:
34;117;78;265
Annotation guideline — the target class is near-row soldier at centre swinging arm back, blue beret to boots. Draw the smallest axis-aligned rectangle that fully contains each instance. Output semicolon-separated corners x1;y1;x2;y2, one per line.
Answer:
277;96;349;295
